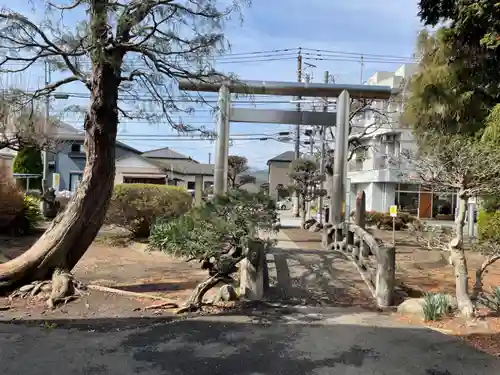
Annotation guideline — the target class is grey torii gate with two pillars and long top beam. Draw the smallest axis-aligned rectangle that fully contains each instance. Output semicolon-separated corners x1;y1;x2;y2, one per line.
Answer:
179;79;395;224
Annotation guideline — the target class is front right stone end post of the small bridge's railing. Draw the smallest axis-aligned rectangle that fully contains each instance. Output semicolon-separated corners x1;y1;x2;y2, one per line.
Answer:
375;246;396;307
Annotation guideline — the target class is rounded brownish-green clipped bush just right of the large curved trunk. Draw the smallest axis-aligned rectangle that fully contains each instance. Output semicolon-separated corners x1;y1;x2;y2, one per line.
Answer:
105;184;193;238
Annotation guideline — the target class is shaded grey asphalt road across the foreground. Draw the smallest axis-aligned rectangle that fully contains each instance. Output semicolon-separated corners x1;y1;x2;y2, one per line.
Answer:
0;308;500;375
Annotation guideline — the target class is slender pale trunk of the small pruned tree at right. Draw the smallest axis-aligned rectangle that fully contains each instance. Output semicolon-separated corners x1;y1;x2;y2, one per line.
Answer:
450;194;474;317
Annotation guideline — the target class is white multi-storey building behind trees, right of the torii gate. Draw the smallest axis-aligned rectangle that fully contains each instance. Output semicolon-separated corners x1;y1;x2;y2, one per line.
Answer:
347;64;456;220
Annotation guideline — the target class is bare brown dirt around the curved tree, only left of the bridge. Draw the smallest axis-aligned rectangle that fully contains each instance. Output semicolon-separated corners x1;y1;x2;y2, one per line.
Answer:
0;231;215;319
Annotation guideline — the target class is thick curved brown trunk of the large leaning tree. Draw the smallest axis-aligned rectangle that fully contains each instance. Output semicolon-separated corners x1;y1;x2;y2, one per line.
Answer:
0;63;119;290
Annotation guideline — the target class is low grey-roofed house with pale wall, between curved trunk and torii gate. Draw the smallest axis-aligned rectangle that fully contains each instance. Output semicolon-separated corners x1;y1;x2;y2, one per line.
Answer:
115;147;214;190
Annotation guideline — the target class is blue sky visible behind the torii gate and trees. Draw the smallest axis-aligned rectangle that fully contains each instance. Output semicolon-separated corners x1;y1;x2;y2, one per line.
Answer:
2;0;422;168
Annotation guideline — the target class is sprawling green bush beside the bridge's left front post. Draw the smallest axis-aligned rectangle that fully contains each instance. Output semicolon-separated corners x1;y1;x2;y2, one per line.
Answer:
149;190;278;272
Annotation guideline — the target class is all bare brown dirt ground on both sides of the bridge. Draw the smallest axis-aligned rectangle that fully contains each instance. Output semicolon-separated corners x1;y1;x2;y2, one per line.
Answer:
0;225;500;355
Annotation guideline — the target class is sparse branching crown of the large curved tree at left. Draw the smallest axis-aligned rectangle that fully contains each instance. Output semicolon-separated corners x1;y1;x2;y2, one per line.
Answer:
0;0;247;147
